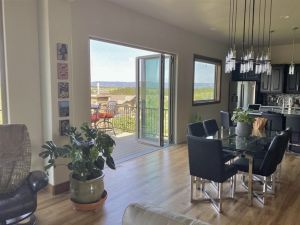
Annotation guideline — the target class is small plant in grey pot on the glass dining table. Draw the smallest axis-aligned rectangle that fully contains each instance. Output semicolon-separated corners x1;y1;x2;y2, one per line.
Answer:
231;109;254;137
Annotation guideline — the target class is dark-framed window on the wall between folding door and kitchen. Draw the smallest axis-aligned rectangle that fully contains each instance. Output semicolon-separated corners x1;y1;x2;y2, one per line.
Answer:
193;55;222;105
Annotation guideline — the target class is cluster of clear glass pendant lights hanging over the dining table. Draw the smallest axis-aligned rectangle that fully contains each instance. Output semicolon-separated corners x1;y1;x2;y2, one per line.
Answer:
225;0;272;75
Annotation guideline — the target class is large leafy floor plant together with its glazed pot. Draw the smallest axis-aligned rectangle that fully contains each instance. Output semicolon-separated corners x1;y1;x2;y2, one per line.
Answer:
39;123;116;207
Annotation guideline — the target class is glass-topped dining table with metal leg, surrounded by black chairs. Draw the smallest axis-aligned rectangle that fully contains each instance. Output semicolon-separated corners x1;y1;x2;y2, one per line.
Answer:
207;127;277;205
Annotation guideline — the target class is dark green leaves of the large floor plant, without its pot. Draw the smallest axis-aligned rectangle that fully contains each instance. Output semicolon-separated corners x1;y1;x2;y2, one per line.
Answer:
39;123;116;181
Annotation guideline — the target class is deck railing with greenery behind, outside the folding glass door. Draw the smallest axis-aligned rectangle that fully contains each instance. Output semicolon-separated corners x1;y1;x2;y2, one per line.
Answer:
105;106;168;137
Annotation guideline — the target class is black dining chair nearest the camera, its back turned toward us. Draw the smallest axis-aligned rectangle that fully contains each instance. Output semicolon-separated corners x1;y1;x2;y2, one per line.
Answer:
187;135;237;212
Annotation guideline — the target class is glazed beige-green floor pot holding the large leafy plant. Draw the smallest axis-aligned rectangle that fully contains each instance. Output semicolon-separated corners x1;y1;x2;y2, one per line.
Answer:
70;174;104;204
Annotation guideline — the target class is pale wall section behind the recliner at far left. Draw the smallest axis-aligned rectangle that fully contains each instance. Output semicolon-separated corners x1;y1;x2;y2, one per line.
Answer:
3;0;42;169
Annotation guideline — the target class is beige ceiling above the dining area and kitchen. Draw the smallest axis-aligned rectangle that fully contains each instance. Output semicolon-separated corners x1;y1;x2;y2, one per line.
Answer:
106;0;300;45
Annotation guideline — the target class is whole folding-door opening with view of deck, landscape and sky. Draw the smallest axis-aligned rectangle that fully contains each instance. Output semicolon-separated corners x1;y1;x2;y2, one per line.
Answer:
90;39;174;161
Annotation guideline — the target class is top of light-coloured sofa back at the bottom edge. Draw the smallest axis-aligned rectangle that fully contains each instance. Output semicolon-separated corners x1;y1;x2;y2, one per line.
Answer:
122;203;208;225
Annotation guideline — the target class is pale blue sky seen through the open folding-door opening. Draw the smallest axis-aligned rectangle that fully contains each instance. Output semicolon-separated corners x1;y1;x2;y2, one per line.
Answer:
90;40;157;82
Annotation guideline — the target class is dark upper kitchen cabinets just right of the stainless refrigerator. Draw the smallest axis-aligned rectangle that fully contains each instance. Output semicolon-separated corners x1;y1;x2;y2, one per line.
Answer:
260;65;285;93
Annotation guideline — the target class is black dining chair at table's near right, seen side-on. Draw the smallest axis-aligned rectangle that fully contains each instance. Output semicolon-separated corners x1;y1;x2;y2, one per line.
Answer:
233;134;287;204
